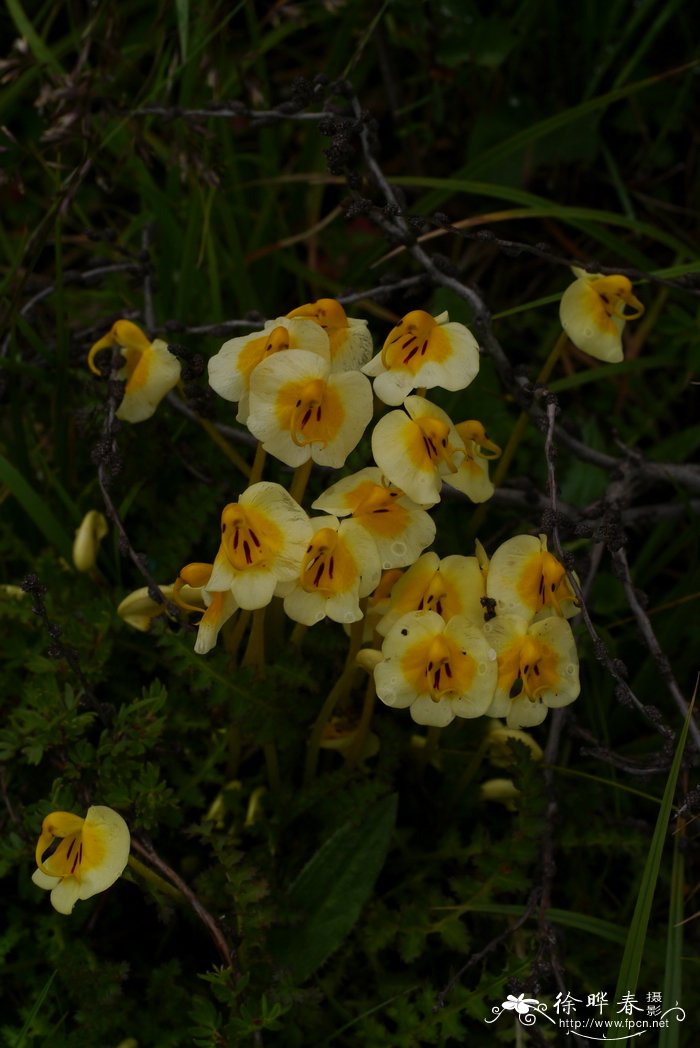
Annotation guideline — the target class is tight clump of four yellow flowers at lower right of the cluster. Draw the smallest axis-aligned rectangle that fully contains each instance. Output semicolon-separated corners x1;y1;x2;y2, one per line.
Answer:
360;536;578;728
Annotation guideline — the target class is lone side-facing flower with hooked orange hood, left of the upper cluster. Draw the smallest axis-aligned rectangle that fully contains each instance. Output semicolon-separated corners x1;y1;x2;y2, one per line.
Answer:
88;321;180;422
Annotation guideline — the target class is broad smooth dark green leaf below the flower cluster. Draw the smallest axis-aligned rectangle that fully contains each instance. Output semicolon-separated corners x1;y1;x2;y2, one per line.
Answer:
271;793;397;981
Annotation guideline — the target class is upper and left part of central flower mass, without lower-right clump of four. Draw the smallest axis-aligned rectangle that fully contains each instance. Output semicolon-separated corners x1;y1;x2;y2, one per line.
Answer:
113;299;500;654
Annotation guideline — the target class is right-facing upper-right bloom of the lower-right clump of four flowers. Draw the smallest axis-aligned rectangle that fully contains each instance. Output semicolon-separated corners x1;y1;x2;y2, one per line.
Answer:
486;534;578;620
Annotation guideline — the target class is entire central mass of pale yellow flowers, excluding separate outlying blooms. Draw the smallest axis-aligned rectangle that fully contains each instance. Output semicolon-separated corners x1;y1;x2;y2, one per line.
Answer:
106;299;578;729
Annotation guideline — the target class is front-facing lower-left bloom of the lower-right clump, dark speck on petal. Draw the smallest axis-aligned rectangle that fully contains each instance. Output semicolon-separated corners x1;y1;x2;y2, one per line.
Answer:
374;611;496;727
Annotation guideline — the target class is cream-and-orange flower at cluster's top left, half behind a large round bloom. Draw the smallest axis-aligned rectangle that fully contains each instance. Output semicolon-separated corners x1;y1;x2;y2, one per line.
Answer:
209;316;330;423
